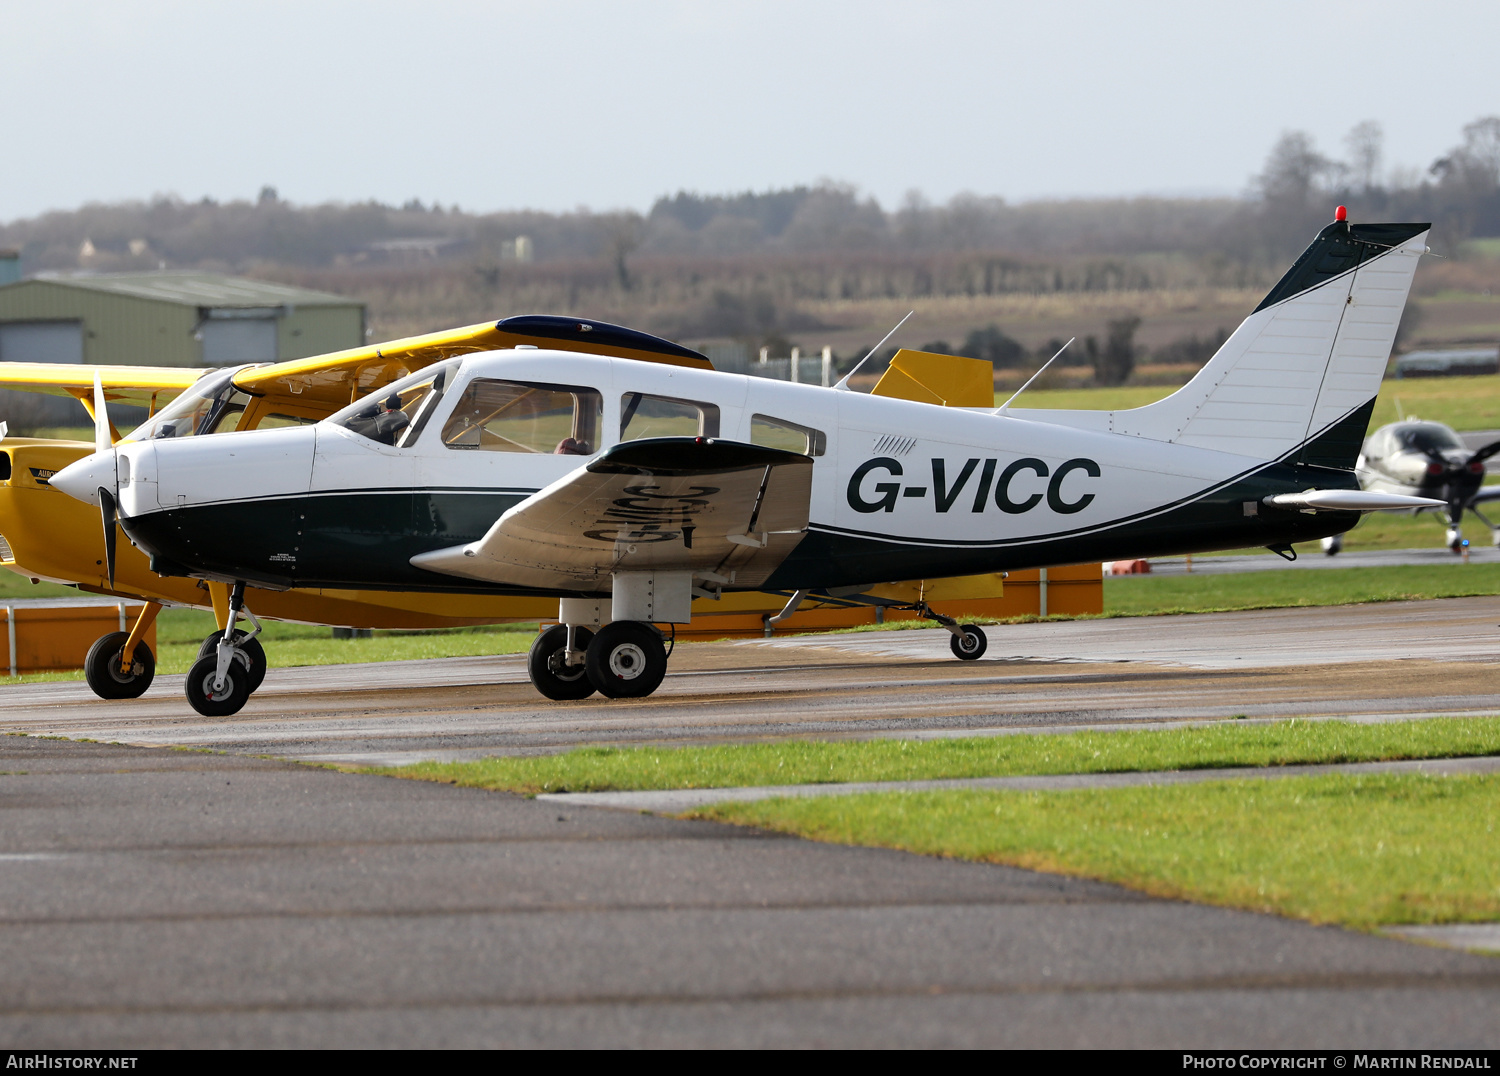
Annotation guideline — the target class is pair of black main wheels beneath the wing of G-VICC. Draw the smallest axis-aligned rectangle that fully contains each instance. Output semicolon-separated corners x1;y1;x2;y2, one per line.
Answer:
527;620;672;702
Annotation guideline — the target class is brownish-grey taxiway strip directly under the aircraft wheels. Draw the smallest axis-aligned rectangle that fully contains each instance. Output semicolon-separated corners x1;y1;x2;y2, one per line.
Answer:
0;597;1500;765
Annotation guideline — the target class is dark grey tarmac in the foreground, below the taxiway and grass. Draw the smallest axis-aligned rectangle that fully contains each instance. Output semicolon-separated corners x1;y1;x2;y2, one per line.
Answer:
0;737;1500;1049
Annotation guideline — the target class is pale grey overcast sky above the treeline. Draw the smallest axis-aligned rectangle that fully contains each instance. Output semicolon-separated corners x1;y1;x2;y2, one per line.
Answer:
0;0;1500;221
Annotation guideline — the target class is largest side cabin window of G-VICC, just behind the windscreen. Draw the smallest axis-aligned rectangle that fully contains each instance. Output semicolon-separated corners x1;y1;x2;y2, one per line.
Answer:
443;378;605;456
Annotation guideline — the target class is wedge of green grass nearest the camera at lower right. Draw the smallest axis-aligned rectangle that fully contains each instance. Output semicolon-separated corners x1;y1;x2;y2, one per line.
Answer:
689;774;1500;929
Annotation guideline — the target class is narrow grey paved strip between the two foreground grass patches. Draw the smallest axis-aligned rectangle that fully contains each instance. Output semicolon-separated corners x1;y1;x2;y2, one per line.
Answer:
537;756;1500;815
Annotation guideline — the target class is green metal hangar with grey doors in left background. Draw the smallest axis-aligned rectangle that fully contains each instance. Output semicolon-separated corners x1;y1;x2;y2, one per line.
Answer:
0;268;365;366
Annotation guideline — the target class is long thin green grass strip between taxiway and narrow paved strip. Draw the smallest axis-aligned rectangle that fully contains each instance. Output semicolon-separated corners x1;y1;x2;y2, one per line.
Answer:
378;717;1500;794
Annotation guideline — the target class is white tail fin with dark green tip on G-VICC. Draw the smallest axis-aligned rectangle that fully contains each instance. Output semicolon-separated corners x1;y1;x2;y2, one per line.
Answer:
1013;221;1431;468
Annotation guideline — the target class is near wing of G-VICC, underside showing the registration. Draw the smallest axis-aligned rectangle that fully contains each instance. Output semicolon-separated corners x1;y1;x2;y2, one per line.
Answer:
411;437;813;593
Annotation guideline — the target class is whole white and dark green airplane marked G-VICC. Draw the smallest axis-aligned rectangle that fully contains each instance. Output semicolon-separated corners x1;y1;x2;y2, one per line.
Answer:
53;207;1434;716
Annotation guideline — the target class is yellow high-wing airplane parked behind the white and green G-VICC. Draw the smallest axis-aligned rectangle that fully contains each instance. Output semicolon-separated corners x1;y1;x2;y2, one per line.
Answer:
0;315;1001;698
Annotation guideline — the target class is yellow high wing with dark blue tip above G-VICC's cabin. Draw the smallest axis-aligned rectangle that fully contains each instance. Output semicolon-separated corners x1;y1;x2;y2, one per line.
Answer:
234;315;713;414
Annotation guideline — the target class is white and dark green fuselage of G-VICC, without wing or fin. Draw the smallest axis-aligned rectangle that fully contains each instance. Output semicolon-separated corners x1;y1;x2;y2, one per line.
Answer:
105;350;1358;593
